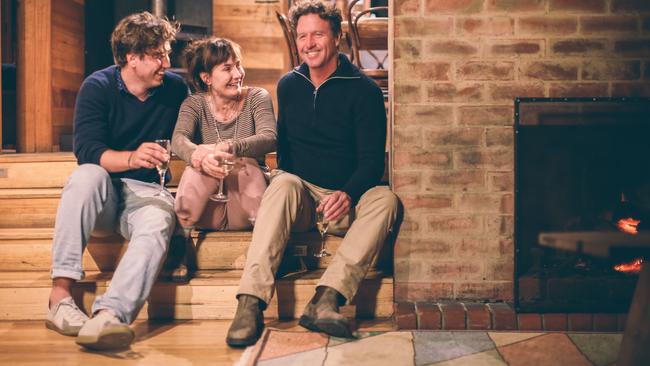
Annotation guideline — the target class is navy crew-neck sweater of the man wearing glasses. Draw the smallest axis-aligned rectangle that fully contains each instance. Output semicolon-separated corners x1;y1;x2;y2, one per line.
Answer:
74;66;188;182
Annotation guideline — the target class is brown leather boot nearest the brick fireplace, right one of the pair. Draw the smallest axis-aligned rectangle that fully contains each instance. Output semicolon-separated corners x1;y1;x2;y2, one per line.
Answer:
298;286;354;338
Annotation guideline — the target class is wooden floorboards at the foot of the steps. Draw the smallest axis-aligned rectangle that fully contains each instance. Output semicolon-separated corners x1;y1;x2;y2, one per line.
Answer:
0;319;392;366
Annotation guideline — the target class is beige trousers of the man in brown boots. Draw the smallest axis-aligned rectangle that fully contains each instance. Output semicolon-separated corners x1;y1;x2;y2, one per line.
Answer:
237;169;398;304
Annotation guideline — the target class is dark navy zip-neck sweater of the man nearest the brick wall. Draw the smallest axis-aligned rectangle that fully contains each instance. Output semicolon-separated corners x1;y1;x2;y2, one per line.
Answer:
278;54;386;203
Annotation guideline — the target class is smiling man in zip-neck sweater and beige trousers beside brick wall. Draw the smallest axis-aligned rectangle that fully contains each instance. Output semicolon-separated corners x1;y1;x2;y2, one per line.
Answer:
226;0;398;346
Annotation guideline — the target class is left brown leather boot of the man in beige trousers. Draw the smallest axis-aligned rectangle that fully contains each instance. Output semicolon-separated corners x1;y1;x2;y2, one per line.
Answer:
226;295;264;347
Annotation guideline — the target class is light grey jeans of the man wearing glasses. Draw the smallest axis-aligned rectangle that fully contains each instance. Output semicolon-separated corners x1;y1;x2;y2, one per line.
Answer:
51;164;176;323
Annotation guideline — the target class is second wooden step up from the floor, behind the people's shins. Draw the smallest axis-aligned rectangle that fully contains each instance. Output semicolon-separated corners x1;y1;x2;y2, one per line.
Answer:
0;228;391;272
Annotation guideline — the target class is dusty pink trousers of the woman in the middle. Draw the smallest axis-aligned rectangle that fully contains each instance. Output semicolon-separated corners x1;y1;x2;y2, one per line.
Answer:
174;158;266;230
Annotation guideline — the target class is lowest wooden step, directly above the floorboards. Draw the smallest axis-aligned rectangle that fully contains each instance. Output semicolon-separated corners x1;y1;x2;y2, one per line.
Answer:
0;270;393;320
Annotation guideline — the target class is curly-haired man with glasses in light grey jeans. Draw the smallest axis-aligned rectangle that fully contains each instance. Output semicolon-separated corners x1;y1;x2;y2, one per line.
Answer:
45;12;187;350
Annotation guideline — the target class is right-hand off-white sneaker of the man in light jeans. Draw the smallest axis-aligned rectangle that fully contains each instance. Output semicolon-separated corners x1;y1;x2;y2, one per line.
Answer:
76;310;135;350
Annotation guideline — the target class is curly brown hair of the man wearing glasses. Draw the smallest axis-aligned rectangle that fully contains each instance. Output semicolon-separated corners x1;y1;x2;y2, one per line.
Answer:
111;11;179;66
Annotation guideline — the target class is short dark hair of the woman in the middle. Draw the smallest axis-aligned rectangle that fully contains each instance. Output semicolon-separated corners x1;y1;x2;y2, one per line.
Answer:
184;38;241;91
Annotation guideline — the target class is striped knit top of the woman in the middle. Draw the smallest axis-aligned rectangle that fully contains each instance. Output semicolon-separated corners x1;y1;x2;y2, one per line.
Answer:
172;87;277;164
